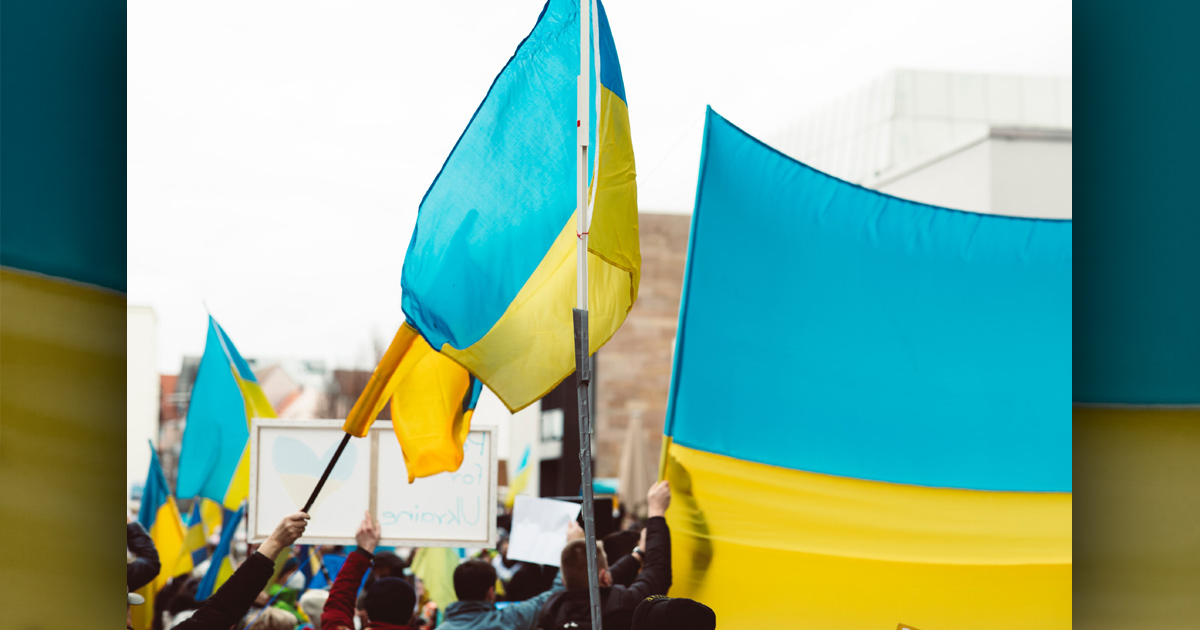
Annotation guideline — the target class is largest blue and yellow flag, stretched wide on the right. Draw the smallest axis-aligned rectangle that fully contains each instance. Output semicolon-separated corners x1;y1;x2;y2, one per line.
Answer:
664;110;1072;630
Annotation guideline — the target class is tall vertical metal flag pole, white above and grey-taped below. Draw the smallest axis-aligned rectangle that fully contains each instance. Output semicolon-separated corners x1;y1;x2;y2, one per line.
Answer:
574;0;601;630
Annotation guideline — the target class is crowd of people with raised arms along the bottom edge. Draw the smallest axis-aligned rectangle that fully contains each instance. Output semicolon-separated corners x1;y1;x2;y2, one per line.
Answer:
127;481;716;630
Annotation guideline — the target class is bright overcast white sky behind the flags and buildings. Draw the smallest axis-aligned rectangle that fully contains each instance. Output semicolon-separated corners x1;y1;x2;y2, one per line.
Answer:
128;0;1072;373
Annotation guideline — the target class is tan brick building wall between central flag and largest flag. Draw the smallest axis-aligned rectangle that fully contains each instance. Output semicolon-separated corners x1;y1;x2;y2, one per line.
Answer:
593;212;691;476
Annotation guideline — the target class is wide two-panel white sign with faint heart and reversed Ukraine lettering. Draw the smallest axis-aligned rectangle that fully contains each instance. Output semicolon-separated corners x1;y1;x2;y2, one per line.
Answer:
250;418;497;548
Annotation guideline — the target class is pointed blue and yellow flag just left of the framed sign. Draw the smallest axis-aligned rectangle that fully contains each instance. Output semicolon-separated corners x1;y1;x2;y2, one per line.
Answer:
175;317;275;510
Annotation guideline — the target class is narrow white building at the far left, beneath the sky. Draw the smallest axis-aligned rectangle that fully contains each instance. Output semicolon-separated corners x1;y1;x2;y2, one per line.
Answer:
125;306;160;496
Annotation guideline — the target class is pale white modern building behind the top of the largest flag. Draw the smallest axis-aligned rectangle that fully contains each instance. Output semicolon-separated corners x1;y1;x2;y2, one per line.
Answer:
764;70;1072;218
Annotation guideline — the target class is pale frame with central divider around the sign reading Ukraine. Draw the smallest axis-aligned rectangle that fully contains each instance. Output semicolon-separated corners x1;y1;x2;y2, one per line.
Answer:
246;418;499;548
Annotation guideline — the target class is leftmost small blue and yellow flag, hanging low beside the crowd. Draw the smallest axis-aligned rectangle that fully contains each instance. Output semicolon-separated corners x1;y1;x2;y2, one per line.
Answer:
132;446;192;630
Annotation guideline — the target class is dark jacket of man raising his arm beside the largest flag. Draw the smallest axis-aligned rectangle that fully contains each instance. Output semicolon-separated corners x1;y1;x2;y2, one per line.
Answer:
538;516;671;630
